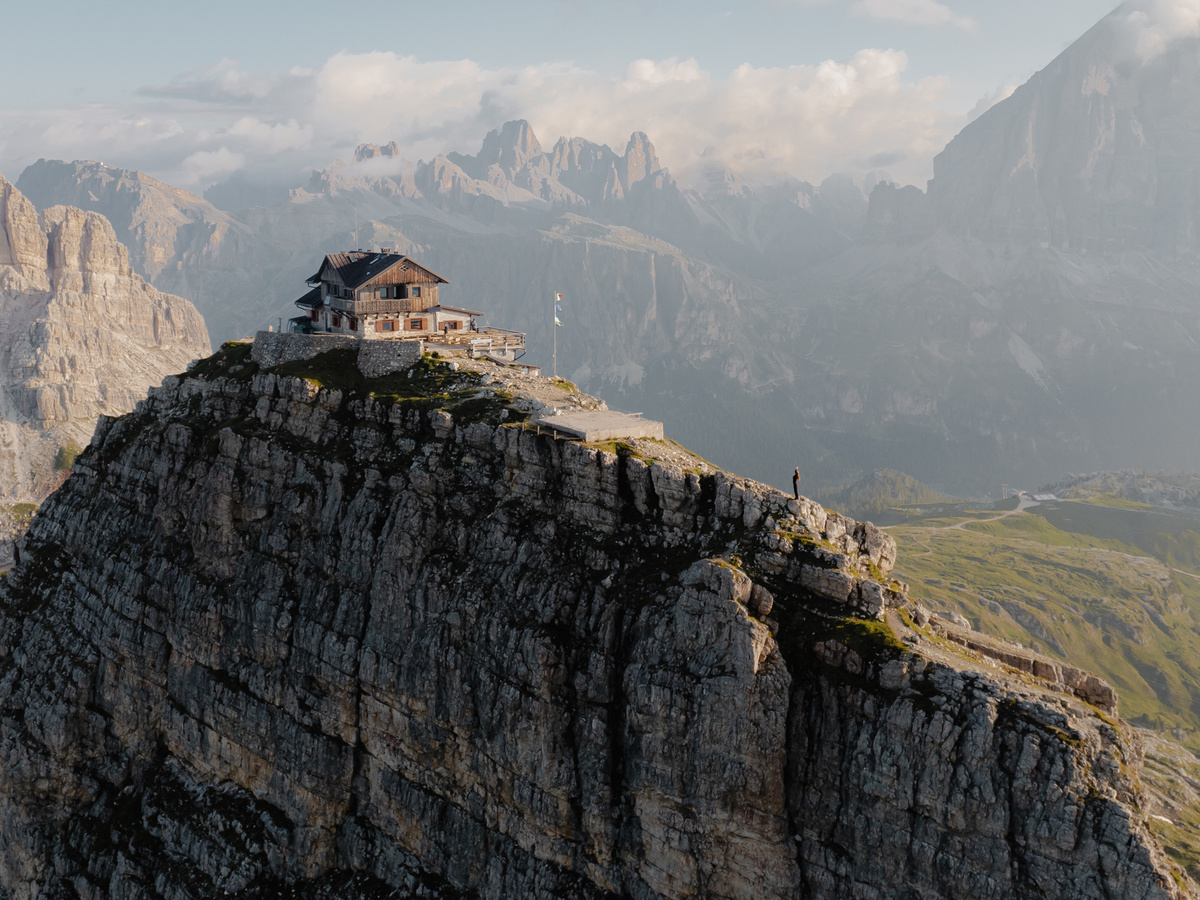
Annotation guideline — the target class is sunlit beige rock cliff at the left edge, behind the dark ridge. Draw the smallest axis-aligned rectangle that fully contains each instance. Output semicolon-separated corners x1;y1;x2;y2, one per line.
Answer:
0;172;209;500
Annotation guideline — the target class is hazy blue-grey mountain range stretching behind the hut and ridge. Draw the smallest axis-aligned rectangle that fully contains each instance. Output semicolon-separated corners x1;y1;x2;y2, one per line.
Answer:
17;3;1200;496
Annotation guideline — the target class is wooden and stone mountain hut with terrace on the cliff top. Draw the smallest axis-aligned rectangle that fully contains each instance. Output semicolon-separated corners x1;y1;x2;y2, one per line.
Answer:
292;250;524;360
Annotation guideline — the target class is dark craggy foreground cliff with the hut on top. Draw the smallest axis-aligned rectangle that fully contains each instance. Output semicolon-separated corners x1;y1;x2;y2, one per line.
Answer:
0;346;1187;900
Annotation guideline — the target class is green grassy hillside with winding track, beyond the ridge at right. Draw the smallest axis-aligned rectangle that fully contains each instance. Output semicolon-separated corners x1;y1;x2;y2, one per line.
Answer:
888;497;1200;750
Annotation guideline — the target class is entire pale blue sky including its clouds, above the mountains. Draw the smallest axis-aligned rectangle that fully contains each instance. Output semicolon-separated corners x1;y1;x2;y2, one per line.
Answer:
0;0;1115;188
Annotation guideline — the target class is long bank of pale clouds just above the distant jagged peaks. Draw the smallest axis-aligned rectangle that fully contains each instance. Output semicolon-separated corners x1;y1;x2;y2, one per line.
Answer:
0;49;966;191
